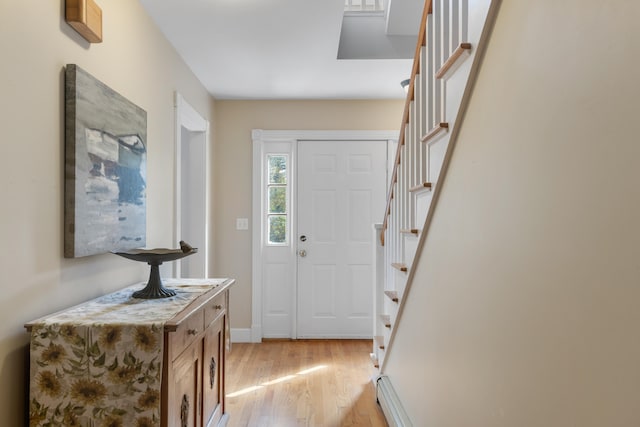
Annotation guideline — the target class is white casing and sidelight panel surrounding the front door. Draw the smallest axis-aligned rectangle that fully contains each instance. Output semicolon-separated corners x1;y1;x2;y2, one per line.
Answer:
250;129;398;342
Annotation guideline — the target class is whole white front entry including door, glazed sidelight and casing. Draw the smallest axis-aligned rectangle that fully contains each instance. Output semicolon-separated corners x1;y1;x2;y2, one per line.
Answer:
250;129;397;342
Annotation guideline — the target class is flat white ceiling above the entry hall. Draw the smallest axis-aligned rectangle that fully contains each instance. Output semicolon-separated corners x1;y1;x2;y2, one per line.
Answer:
140;0;423;99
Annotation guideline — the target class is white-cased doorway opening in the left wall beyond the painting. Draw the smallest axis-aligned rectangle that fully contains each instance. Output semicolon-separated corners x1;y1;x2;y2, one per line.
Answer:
173;93;210;277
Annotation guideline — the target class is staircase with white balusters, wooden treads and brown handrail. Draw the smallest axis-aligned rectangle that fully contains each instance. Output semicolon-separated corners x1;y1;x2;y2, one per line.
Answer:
371;0;498;374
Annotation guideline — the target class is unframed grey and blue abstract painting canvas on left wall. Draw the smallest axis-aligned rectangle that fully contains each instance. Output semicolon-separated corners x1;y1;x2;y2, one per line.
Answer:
64;64;147;258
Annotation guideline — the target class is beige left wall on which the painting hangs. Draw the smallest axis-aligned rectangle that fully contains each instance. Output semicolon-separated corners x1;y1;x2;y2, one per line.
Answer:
0;0;213;426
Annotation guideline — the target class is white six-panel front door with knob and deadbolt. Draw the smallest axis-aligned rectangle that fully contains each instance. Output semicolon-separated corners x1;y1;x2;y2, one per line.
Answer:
294;141;387;338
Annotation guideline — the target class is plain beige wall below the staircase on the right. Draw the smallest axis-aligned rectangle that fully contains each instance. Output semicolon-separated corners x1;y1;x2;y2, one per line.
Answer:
386;0;640;427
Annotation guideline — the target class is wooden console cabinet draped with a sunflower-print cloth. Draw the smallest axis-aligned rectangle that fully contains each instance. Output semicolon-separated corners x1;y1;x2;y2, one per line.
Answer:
26;279;234;427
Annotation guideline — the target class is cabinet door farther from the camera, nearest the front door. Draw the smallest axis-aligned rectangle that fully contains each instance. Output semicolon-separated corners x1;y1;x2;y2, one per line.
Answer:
202;316;226;426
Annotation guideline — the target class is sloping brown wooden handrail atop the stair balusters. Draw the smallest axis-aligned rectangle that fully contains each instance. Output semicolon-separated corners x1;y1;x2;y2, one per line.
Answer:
380;0;432;246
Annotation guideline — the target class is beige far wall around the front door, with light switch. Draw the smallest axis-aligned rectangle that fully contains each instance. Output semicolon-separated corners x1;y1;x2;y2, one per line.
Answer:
213;100;404;329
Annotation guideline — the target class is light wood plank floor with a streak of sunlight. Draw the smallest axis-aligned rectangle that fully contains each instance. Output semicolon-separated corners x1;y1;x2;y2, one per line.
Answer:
225;340;387;427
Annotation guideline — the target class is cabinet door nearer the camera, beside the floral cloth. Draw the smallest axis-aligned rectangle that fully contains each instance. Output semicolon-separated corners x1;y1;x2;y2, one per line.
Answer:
168;340;202;427
